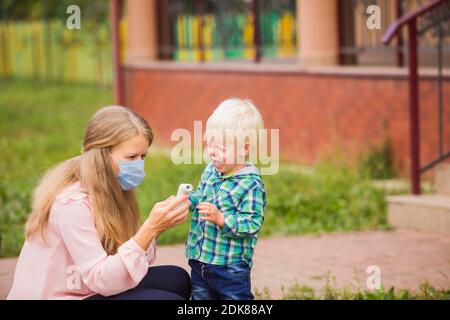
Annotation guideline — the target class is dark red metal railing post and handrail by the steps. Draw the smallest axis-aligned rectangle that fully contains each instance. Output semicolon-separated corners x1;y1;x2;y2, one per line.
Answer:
383;0;449;195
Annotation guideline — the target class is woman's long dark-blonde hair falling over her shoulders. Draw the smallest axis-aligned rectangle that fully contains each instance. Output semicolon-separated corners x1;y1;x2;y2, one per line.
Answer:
25;106;153;254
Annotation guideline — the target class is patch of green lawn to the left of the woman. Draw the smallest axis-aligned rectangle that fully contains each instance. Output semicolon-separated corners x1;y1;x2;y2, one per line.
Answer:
0;80;112;256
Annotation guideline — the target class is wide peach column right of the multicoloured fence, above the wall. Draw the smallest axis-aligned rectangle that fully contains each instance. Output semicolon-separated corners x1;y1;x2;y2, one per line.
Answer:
297;0;339;66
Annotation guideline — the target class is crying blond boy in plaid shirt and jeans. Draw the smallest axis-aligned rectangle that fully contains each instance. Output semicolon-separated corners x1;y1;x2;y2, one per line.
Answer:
186;99;266;300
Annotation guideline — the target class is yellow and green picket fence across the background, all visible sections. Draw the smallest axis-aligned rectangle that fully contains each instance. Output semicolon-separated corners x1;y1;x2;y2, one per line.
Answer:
0;12;296;85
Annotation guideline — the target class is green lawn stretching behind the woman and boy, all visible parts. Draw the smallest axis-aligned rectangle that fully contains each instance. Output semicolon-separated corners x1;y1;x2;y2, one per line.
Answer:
0;81;388;256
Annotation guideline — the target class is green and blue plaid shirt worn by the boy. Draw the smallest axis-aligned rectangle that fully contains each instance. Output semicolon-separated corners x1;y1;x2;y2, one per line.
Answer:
186;163;266;267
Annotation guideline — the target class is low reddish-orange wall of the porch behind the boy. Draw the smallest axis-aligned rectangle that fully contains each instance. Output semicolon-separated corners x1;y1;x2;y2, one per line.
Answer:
125;68;450;173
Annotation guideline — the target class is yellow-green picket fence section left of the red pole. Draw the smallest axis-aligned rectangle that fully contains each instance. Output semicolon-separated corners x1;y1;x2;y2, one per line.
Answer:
0;20;112;85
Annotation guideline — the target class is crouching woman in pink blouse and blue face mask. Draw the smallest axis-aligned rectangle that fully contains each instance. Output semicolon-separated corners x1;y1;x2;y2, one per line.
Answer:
8;106;190;299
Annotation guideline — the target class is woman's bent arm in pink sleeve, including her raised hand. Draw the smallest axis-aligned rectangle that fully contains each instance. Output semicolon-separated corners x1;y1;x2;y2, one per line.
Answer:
53;194;189;296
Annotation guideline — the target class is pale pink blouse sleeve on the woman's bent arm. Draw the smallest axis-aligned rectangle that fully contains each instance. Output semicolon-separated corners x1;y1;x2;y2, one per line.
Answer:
52;200;148;296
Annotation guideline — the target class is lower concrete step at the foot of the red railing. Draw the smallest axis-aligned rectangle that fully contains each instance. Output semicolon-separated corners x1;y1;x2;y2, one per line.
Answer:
387;194;450;235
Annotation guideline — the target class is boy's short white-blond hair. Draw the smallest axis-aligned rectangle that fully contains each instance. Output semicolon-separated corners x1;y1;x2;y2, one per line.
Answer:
206;98;264;148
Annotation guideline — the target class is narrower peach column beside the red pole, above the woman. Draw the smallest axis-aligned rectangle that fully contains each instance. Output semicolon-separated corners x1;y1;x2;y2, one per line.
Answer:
125;0;158;61
